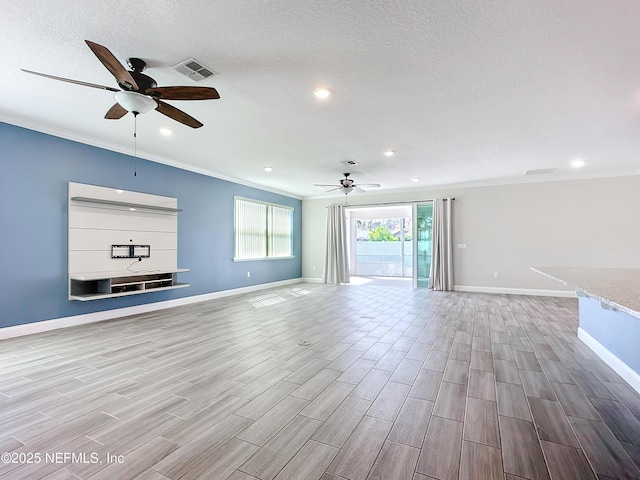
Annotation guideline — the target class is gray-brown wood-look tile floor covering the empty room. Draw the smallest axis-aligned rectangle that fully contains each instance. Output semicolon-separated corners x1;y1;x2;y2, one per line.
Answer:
0;284;640;480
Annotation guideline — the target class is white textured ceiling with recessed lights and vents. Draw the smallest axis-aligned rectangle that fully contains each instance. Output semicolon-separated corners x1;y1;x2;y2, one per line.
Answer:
0;0;640;197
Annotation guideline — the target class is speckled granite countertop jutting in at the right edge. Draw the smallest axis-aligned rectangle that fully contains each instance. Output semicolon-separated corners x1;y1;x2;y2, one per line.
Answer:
531;267;640;318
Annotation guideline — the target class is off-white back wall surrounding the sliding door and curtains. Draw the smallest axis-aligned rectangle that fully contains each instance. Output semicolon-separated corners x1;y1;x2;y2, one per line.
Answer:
302;176;640;292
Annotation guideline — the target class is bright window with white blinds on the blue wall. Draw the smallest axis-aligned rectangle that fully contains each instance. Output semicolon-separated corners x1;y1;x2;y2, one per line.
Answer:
234;197;293;260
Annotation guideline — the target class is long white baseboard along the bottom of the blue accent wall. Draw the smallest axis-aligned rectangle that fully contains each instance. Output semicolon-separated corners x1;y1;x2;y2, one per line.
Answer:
0;278;305;340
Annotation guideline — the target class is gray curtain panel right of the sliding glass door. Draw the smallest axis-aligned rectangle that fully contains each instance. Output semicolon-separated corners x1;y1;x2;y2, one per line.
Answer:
429;198;453;290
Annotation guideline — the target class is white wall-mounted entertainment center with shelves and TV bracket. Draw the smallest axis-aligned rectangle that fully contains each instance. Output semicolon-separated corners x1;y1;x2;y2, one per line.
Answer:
68;182;189;301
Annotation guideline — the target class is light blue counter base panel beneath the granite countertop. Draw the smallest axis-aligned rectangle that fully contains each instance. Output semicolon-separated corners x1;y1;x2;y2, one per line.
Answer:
578;297;640;374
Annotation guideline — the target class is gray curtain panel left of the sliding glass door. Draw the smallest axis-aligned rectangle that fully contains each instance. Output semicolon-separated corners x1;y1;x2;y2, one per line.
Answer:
324;205;349;284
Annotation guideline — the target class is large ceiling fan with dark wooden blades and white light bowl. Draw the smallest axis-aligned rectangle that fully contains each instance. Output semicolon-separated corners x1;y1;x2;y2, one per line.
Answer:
22;40;220;128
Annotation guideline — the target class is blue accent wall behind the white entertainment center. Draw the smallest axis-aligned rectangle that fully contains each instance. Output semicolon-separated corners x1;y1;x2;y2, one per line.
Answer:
0;122;302;328
